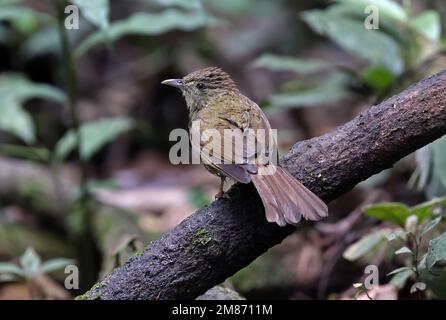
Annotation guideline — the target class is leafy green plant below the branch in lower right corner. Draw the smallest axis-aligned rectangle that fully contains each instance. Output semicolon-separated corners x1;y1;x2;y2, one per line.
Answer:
343;197;446;298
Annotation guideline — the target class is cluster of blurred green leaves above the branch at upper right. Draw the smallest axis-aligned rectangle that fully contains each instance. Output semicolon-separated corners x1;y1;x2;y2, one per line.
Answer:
255;0;442;108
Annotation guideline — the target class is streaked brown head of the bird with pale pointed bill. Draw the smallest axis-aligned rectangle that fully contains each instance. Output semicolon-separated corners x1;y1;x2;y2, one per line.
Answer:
162;67;237;111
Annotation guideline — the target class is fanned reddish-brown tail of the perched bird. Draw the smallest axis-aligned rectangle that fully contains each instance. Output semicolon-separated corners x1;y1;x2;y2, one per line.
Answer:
251;165;328;226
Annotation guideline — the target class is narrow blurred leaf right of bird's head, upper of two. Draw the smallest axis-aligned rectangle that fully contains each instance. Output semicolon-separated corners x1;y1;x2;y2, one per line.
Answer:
254;54;331;74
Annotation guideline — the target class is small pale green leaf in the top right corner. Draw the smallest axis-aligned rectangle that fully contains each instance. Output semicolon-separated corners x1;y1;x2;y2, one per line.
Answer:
409;10;441;43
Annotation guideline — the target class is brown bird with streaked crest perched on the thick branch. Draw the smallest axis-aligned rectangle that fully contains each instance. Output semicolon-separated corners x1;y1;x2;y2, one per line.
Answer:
162;67;328;227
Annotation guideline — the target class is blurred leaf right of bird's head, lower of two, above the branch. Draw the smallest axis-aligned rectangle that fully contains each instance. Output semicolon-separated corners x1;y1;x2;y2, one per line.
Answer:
268;74;352;108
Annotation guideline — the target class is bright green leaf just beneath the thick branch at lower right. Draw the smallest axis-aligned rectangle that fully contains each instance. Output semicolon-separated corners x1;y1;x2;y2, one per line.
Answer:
363;202;410;228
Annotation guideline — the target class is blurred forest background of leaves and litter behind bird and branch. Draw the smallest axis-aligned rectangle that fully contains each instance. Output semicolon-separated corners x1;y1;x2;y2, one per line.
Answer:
0;0;446;299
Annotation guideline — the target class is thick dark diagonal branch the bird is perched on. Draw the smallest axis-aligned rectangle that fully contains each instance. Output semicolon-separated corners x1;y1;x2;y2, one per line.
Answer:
86;72;446;299
